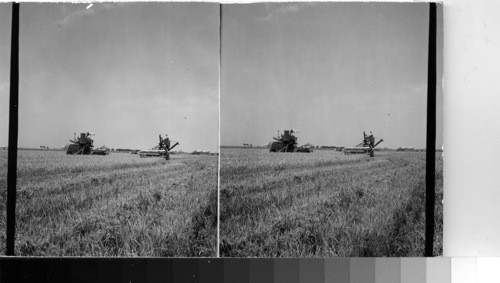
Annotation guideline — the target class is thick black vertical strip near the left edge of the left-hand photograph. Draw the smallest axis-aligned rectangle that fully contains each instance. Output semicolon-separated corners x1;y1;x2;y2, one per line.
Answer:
6;3;19;255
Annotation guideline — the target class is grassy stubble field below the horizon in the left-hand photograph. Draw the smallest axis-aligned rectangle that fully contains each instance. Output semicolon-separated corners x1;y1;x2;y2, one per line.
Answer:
0;150;218;257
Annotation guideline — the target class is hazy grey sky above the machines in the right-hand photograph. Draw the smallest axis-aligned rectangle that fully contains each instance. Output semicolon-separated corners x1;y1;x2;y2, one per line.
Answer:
220;3;443;148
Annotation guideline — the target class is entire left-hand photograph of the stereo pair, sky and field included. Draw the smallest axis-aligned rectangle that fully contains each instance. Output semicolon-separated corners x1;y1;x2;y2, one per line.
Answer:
0;3;219;257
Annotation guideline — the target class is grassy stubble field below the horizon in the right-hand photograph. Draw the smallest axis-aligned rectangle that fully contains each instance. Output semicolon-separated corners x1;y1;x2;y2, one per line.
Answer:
219;148;443;257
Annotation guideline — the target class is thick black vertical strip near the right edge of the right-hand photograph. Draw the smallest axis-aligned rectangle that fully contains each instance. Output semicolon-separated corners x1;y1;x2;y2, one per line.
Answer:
424;3;436;257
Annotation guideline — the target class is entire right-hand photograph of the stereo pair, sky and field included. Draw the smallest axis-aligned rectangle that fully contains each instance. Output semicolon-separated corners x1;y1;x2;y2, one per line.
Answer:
219;2;443;257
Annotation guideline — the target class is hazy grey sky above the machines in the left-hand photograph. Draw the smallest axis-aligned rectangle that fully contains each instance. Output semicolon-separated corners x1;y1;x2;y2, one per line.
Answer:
0;3;219;151
